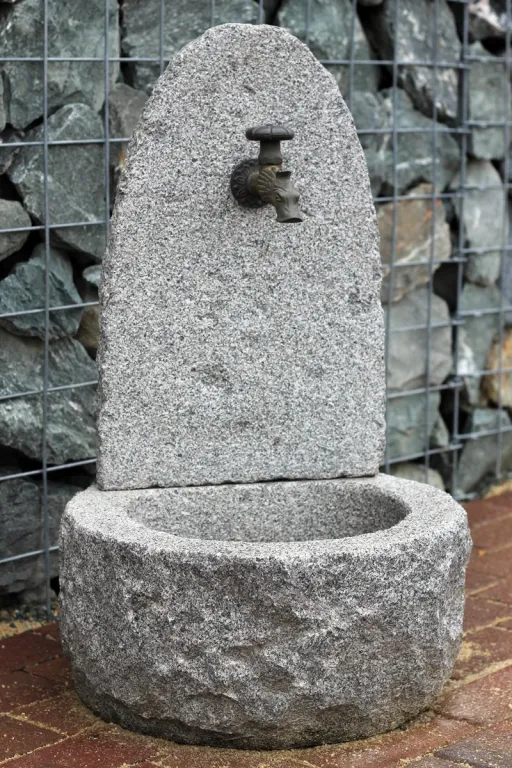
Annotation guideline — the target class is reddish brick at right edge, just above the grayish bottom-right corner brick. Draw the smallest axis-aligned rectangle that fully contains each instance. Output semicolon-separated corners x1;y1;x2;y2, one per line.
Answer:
435;666;512;725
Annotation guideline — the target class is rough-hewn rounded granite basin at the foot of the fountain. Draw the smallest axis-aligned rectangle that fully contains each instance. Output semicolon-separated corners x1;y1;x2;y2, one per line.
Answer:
61;475;471;749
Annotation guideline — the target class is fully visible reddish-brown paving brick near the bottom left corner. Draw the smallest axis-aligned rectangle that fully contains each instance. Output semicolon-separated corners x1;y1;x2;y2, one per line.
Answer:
10;688;98;736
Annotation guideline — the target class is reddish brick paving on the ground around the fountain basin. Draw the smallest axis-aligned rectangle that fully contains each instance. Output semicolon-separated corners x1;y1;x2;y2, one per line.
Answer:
0;493;512;768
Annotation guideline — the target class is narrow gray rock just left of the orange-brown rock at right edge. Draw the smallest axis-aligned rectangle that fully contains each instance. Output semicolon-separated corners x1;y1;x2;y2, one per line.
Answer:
455;283;500;406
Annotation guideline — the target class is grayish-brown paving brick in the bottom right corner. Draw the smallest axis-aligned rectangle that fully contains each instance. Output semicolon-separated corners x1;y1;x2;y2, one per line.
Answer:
436;723;512;768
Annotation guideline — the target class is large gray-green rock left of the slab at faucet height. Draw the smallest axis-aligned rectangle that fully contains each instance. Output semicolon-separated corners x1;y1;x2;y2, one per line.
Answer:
8;104;105;261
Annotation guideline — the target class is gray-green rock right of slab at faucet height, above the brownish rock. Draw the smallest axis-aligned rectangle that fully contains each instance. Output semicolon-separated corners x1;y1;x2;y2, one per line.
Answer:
350;88;460;195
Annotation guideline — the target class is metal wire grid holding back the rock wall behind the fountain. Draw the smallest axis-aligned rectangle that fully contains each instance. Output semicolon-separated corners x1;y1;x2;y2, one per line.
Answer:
0;0;512;615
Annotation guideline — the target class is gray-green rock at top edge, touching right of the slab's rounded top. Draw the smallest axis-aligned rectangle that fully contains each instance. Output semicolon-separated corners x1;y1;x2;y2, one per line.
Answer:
279;0;379;96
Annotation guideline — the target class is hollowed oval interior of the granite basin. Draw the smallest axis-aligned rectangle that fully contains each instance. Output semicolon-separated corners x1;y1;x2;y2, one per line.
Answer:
128;480;410;542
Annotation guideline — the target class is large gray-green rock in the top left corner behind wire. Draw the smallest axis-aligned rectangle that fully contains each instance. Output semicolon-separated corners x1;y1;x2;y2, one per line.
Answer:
0;0;119;130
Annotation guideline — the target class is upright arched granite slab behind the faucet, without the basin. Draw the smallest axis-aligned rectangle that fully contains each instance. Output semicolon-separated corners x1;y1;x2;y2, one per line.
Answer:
99;24;384;490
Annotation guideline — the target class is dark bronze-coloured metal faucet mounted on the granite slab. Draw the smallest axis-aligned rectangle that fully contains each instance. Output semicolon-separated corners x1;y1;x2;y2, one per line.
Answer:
231;125;303;224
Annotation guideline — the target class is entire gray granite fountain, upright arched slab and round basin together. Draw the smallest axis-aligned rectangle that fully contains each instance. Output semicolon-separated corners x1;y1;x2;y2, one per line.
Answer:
61;24;470;749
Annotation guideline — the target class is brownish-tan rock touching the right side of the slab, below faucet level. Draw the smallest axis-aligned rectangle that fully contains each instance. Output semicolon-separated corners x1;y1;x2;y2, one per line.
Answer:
377;184;451;304
